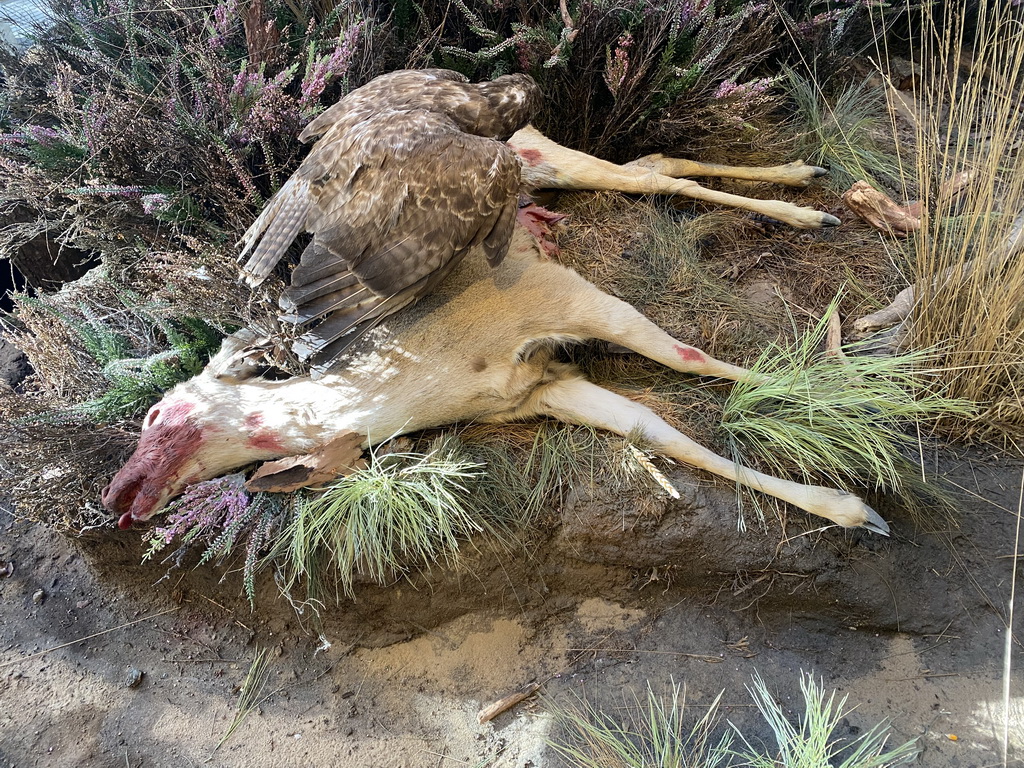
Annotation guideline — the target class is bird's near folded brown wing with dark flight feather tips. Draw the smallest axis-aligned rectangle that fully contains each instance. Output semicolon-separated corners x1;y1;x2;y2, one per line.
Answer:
272;112;520;370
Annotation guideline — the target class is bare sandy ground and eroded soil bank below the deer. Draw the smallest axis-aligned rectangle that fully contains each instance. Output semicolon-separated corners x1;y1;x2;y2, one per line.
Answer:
0;455;1024;768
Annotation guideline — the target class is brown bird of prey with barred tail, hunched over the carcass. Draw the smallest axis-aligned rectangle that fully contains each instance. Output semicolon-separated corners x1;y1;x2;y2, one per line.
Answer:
240;70;541;369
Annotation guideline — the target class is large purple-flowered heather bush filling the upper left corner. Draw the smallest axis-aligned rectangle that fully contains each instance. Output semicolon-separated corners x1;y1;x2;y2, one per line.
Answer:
0;0;368;280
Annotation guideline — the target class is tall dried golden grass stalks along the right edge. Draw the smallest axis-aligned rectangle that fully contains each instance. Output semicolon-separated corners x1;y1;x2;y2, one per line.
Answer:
912;3;1024;440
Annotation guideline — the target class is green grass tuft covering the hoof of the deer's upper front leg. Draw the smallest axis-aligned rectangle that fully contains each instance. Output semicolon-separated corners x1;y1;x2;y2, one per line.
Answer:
722;296;973;507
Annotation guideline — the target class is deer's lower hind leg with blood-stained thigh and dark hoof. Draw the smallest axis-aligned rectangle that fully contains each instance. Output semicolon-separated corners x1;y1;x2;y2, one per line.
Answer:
509;126;840;229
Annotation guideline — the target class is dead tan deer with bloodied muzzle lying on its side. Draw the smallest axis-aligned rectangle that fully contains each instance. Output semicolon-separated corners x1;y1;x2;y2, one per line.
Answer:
102;128;888;534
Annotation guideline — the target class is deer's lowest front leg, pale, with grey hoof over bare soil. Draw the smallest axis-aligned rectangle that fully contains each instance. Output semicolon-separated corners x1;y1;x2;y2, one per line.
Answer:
531;379;889;535
